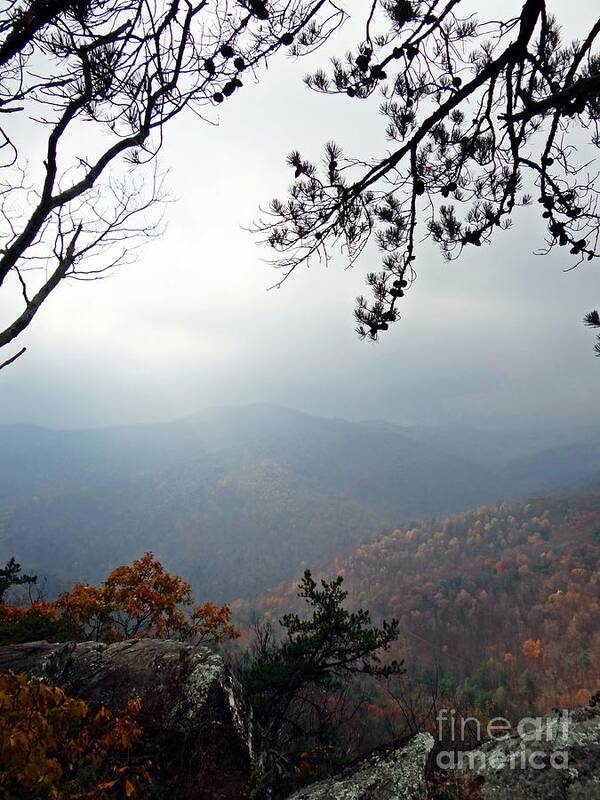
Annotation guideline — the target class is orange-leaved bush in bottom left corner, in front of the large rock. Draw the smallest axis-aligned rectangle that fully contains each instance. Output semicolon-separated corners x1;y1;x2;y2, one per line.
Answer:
0;673;151;800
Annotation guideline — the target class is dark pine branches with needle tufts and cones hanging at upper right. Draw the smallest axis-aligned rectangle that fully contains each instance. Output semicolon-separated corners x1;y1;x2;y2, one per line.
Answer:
257;0;600;340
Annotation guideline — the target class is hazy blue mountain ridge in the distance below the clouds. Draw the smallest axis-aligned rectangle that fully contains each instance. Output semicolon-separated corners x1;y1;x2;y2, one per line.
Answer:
0;405;600;601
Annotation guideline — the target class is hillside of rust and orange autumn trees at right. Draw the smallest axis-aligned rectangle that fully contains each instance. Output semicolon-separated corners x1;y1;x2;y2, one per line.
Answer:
255;489;600;713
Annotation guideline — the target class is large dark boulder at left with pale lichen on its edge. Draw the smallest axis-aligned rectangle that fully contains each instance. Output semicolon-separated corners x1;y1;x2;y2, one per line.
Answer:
0;639;252;800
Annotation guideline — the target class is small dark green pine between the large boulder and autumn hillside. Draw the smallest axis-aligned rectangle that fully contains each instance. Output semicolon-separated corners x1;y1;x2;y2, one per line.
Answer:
240;570;403;785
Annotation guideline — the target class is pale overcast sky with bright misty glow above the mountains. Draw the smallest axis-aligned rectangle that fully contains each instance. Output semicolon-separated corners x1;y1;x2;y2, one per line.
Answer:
0;0;600;429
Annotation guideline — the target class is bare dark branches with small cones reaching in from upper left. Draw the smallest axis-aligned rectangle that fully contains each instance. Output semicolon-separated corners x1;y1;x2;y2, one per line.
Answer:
0;0;344;368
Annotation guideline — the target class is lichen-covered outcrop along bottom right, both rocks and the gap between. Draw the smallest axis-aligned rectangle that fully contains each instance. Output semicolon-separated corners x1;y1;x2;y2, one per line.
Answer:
288;706;600;800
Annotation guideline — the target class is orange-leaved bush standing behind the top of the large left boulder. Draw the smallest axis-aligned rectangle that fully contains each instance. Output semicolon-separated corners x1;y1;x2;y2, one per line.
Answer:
57;553;240;643
